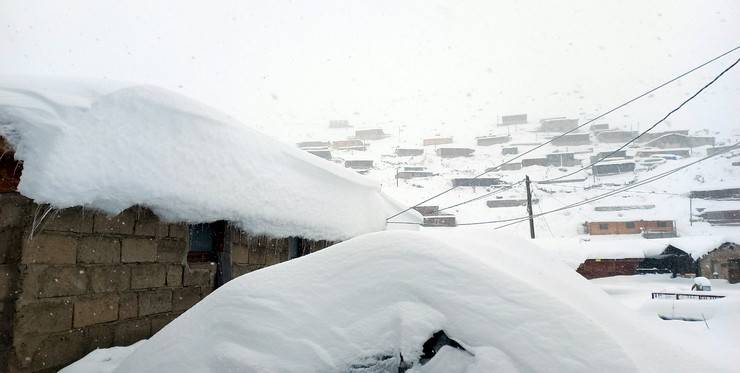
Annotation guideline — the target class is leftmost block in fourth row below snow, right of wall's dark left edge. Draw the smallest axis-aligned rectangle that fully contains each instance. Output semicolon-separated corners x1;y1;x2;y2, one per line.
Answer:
15;299;72;335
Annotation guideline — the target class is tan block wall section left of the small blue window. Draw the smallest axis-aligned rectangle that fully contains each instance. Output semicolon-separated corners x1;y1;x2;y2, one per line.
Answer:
0;193;216;372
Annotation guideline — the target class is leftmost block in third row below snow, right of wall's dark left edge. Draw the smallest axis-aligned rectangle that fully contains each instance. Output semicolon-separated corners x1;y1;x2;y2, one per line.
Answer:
22;265;89;298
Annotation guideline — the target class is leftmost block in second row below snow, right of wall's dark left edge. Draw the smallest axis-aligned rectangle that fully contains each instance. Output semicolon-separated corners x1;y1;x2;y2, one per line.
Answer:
21;233;77;264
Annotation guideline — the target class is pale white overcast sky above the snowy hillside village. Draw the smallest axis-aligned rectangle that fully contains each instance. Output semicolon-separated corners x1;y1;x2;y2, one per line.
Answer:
0;0;740;134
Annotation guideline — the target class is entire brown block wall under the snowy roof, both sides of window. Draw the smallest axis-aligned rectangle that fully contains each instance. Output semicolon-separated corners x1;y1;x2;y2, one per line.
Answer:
0;192;333;372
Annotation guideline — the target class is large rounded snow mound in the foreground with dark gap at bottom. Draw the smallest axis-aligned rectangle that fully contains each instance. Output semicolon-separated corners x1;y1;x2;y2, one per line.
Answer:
65;231;715;373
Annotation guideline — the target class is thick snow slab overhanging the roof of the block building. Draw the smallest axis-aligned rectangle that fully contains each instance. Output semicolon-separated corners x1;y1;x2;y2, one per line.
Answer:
0;78;419;240
